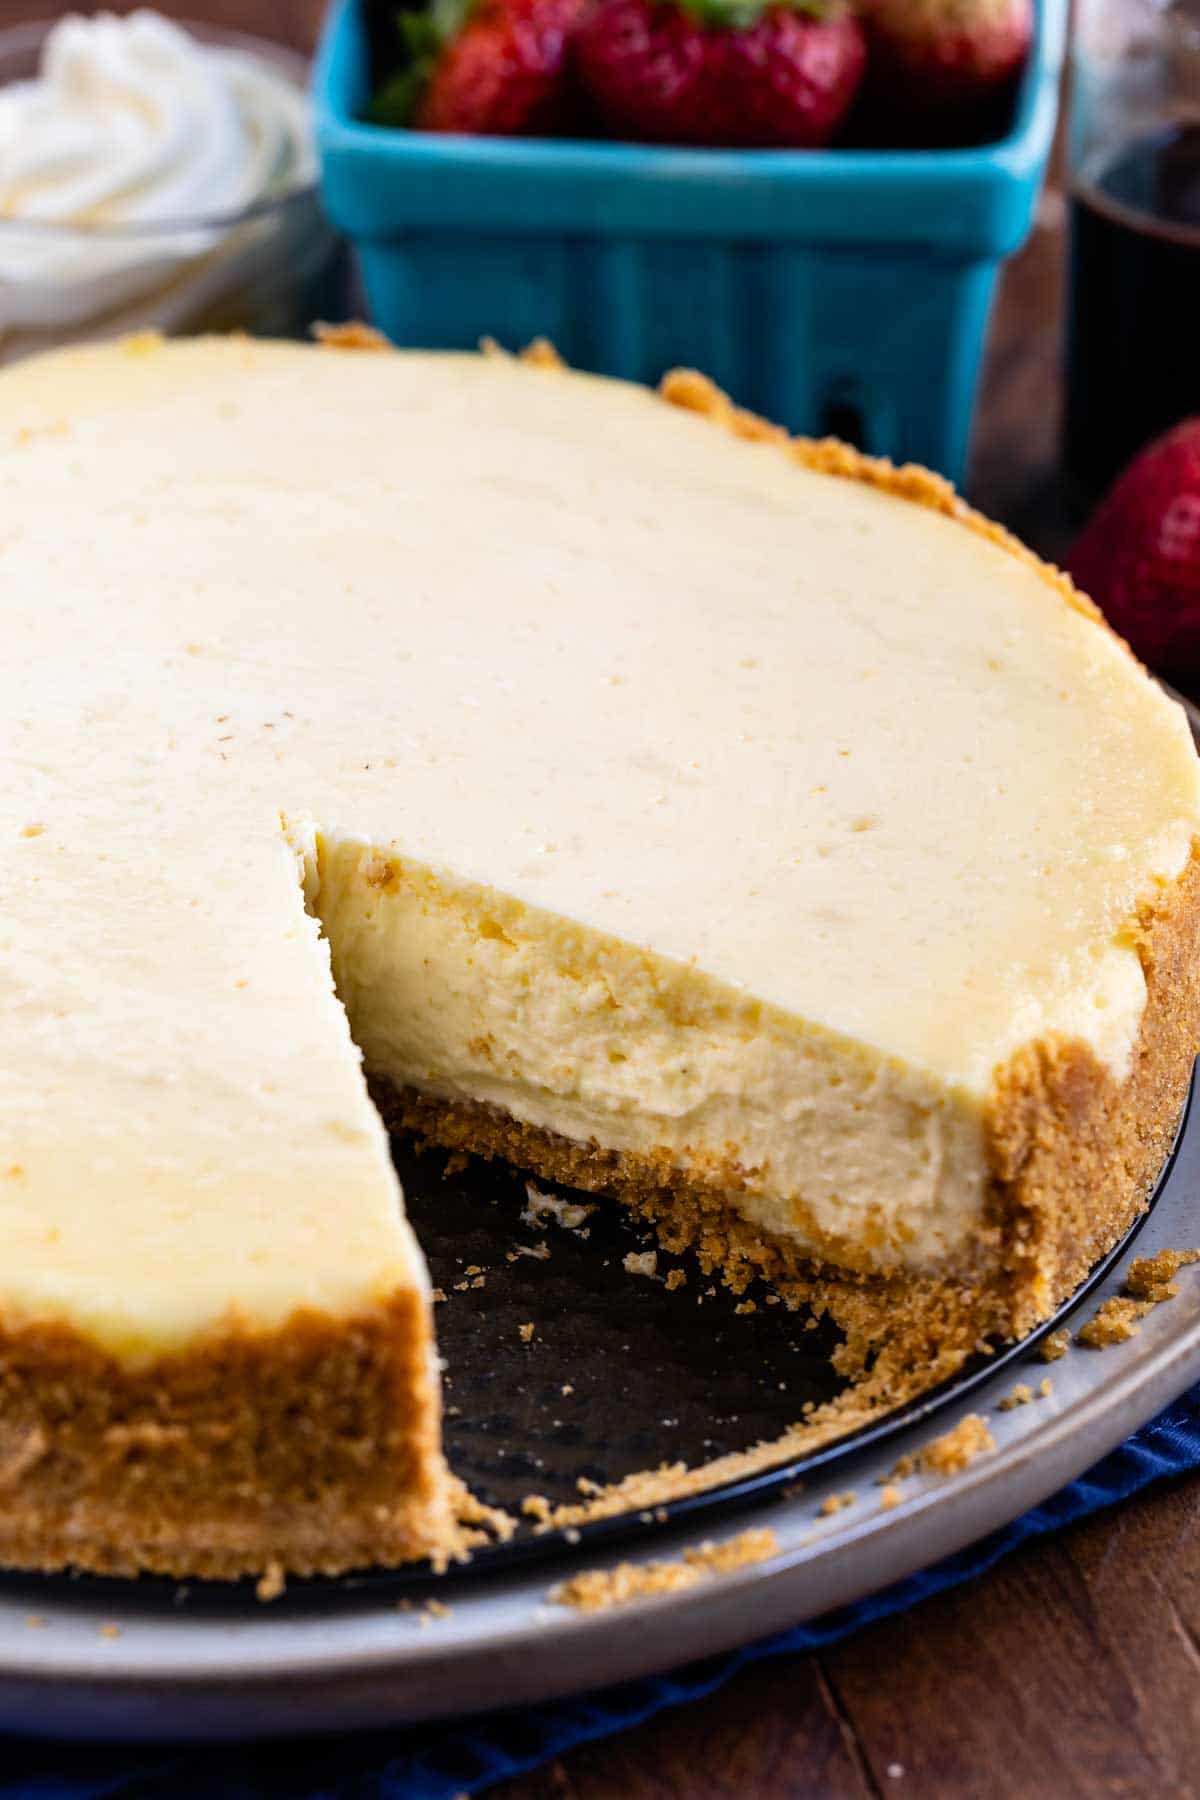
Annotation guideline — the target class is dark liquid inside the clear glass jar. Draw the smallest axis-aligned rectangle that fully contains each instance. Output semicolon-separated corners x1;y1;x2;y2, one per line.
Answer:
1065;126;1200;500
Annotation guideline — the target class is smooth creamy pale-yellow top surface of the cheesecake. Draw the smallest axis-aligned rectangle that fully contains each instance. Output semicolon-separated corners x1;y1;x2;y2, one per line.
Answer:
0;340;1200;1348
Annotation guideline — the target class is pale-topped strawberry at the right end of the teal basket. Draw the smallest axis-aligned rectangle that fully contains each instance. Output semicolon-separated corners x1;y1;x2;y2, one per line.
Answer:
864;0;1033;135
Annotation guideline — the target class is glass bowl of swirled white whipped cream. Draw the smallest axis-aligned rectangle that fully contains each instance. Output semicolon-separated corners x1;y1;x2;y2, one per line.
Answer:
0;11;342;362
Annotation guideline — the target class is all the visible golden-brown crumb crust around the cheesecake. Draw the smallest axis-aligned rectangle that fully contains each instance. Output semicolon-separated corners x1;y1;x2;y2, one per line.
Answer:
0;338;1200;1577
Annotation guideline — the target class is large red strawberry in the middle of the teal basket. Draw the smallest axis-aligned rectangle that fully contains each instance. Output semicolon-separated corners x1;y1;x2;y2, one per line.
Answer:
574;0;867;149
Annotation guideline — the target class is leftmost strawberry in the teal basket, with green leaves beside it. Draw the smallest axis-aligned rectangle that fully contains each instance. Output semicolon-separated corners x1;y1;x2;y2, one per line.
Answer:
371;0;587;137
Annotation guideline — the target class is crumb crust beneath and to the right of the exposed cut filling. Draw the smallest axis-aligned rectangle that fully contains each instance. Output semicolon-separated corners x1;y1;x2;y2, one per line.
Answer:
371;831;1200;1404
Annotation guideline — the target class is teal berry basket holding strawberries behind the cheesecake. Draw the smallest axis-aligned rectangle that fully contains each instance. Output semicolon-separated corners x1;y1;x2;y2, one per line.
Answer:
315;0;1069;482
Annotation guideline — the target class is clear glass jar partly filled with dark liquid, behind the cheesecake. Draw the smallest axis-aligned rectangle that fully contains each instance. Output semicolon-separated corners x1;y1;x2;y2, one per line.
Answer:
1063;0;1200;504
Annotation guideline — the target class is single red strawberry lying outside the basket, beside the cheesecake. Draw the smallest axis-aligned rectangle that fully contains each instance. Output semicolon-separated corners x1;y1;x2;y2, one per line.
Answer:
1067;418;1200;693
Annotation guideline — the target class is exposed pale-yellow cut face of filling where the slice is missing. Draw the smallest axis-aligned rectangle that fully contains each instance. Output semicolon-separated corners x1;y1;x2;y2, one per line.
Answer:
302;826;986;1273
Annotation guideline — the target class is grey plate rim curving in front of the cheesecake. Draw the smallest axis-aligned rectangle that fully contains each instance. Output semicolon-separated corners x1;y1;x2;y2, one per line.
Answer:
0;1137;1200;1741
